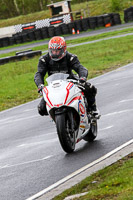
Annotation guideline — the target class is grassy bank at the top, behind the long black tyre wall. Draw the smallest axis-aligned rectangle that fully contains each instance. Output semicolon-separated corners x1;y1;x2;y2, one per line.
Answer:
0;0;132;27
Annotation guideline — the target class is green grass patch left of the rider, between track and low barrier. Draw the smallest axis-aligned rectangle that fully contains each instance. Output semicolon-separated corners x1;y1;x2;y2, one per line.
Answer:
0;58;38;110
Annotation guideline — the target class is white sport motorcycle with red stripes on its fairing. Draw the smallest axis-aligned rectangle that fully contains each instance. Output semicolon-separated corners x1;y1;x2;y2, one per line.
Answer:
42;73;100;153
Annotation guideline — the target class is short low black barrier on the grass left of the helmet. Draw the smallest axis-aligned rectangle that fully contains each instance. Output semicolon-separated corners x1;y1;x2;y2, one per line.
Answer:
0;49;42;65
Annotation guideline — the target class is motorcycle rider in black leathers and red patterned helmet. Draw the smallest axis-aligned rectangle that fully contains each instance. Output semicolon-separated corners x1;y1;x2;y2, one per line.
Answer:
34;36;98;116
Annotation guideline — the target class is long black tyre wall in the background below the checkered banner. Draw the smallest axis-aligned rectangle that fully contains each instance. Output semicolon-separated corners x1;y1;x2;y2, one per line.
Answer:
0;12;122;47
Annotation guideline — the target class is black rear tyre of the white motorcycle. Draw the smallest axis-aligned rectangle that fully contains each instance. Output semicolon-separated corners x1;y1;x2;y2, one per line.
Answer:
83;120;97;142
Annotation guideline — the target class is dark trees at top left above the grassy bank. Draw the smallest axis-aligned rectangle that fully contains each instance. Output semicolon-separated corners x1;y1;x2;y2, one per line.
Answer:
0;0;86;19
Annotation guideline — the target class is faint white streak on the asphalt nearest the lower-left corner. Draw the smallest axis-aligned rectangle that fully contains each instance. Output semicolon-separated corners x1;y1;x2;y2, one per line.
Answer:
0;155;52;169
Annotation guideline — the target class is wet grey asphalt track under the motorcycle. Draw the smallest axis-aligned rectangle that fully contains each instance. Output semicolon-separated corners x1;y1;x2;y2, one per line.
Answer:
0;64;133;200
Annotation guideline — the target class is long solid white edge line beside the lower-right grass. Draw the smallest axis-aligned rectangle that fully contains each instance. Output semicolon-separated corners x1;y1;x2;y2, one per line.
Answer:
26;139;133;200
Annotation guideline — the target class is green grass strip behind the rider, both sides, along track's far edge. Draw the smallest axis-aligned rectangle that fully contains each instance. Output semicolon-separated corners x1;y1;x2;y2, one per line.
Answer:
0;30;133;111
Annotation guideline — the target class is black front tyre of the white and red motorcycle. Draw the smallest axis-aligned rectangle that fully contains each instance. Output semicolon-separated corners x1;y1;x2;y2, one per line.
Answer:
55;113;75;153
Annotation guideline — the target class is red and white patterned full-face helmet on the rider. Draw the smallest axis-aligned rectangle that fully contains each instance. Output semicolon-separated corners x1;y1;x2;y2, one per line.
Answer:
48;36;66;61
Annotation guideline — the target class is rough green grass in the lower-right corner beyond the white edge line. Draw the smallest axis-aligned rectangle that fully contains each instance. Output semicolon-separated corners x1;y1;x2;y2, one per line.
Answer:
53;153;133;200
